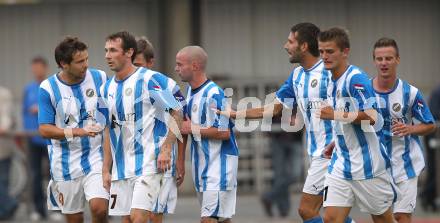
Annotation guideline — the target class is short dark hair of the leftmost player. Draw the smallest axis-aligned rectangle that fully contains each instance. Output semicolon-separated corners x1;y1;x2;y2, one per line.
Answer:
55;36;87;68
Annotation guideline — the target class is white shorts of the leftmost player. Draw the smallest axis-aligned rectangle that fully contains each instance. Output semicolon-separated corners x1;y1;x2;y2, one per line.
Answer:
47;173;109;214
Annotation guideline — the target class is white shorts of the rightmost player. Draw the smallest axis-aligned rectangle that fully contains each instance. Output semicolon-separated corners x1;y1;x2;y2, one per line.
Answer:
393;177;418;213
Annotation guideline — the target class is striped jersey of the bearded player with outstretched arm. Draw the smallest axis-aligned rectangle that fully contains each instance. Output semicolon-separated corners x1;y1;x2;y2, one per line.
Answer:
276;60;333;157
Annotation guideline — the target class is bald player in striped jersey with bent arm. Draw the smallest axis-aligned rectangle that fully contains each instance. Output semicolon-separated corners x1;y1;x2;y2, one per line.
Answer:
175;46;238;223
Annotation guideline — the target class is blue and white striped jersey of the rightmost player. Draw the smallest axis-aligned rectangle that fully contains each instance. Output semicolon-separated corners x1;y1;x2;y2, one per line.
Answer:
376;79;434;183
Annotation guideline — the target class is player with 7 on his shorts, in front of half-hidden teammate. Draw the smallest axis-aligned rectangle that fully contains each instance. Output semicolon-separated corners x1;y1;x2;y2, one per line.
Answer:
101;31;182;223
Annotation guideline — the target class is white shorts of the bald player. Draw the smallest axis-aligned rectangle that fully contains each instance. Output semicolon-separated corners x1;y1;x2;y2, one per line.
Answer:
197;188;237;221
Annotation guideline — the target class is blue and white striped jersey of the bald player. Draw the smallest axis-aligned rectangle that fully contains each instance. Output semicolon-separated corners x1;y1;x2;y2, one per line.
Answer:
185;80;238;192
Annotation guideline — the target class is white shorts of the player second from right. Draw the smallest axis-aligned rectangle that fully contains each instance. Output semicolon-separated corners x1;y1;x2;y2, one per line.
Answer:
323;172;397;215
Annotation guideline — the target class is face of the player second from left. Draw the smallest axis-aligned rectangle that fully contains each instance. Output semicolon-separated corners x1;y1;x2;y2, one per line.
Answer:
105;38;133;72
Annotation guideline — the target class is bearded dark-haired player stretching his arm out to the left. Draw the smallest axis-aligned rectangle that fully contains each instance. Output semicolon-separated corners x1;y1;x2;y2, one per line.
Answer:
221;23;351;223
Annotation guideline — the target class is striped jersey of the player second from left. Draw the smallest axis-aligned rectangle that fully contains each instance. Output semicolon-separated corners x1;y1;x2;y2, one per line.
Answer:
101;68;183;180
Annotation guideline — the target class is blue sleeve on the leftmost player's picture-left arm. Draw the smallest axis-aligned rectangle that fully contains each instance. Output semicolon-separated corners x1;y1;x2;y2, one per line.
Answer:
38;87;55;125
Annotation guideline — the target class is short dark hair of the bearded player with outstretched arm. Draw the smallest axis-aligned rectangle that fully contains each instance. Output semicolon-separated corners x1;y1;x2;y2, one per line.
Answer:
290;22;320;57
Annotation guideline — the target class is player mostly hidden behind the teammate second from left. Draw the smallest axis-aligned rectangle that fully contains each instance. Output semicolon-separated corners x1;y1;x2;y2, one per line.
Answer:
133;38;186;223
